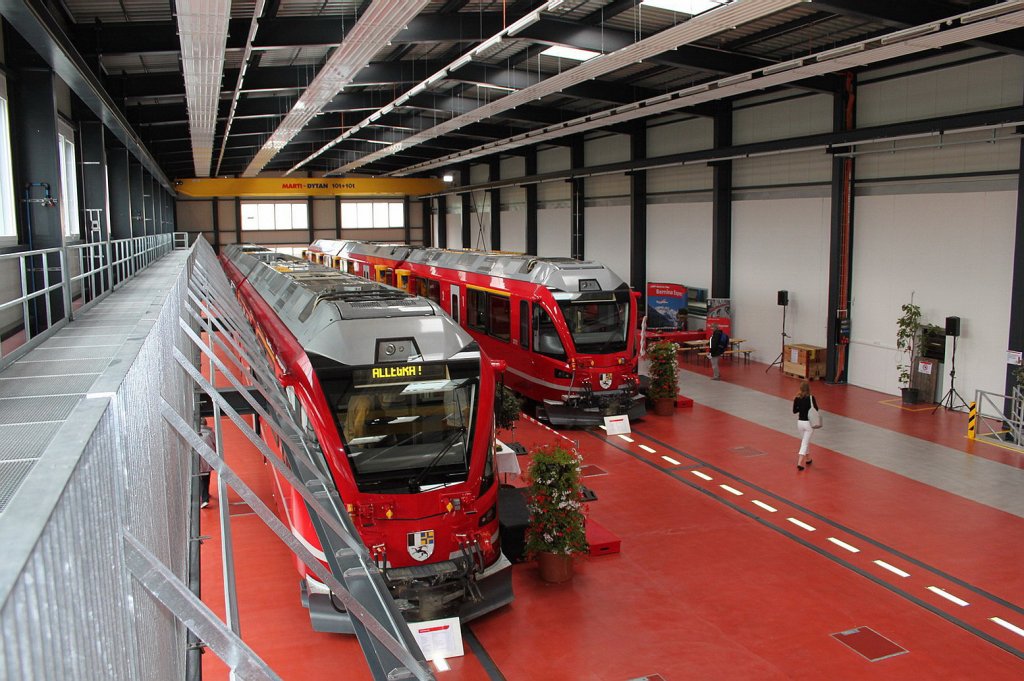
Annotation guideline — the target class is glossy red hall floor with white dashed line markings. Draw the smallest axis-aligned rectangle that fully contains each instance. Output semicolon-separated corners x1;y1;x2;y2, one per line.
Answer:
202;364;1024;681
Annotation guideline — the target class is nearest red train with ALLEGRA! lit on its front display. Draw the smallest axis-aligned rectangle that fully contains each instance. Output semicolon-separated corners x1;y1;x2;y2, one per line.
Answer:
221;246;512;633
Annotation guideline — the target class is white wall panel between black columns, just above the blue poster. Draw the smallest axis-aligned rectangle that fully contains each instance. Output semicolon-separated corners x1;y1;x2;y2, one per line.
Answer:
647;201;712;289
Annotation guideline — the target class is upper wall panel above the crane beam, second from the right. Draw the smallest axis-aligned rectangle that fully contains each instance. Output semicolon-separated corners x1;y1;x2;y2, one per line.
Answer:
732;94;833;144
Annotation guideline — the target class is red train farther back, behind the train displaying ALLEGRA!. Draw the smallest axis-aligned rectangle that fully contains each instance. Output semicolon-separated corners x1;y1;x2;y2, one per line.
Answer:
305;240;645;426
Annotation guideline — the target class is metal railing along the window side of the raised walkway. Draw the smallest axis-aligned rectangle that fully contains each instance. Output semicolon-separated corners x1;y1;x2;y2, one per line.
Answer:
0;232;182;369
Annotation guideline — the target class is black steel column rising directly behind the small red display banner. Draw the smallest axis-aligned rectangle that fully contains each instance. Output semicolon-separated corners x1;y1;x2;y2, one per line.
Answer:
710;102;732;298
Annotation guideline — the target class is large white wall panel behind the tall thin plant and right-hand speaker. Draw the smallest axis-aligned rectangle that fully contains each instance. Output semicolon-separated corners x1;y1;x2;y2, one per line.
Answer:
850;187;1017;399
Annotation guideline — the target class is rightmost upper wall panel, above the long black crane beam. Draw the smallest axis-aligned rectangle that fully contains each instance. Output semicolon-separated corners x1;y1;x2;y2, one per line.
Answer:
857;55;1024;127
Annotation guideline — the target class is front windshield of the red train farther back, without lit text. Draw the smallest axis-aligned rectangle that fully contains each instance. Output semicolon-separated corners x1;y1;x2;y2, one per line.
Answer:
555;291;630;354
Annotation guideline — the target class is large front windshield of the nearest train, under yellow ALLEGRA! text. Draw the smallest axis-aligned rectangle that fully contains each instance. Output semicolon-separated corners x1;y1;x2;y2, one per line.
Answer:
321;360;480;494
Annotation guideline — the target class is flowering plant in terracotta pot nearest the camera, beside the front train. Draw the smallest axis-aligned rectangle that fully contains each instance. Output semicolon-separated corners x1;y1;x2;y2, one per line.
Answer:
525;444;590;584
